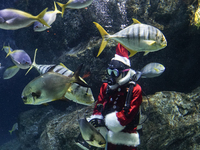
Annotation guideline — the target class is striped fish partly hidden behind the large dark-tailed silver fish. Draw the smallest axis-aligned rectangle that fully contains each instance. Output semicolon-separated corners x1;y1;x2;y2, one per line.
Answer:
26;49;94;105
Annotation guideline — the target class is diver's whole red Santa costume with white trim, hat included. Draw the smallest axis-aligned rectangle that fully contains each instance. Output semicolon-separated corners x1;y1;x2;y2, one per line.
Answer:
90;44;142;150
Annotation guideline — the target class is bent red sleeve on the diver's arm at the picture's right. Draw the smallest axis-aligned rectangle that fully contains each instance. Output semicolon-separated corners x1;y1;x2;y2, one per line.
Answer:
116;84;142;126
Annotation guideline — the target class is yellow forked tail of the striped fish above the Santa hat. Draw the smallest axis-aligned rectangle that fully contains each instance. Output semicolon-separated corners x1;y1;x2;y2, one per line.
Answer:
93;22;109;57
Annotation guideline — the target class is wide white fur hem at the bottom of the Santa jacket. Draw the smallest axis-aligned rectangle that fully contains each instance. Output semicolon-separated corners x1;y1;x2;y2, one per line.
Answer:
108;131;140;147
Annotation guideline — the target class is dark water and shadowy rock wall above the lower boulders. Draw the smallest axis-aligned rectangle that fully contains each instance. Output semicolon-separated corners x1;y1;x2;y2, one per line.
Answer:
0;0;200;144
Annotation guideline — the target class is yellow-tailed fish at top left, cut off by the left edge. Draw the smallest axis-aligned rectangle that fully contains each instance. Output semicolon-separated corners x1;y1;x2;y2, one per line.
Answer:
0;8;50;30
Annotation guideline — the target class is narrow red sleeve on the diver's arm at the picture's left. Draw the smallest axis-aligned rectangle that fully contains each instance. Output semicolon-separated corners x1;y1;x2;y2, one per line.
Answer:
93;83;108;115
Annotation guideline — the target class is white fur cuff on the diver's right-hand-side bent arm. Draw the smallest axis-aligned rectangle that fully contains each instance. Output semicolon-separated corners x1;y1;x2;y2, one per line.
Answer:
105;111;125;132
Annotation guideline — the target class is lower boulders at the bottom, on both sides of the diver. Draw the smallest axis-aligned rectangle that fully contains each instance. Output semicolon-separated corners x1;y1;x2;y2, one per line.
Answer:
0;87;200;150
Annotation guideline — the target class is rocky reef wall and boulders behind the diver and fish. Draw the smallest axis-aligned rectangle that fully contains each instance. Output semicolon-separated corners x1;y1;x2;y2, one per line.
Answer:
0;0;200;150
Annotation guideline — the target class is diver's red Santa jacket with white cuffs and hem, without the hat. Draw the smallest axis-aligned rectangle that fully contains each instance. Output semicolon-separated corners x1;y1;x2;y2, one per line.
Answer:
92;83;142;150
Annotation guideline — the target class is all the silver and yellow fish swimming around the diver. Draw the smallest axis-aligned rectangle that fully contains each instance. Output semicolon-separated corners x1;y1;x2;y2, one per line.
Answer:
0;0;169;145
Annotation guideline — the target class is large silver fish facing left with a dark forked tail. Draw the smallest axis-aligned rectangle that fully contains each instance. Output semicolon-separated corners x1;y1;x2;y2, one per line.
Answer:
22;66;88;105
